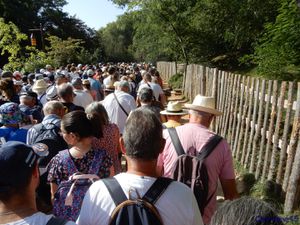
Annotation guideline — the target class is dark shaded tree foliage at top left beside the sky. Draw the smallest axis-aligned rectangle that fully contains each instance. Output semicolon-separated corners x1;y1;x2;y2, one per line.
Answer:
0;0;103;67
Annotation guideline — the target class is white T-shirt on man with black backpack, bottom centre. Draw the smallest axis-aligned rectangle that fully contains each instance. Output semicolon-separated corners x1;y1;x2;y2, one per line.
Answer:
76;173;203;225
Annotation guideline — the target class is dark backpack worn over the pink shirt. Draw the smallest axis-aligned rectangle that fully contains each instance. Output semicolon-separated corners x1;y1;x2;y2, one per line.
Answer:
168;128;222;215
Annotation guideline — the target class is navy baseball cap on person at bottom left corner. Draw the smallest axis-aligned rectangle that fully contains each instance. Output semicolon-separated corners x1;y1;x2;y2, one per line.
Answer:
0;141;49;192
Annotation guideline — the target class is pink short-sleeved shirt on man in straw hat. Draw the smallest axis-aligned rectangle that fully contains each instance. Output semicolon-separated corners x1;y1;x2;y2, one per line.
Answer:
158;123;235;224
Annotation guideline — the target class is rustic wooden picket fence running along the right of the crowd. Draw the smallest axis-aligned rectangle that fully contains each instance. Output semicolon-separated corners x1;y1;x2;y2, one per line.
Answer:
157;62;300;213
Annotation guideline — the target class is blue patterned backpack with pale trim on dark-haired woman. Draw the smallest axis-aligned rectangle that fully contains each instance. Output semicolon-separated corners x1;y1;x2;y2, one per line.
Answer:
53;149;103;221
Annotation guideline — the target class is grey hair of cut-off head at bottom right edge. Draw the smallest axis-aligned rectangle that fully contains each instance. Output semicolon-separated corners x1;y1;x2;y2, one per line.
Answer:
210;197;283;225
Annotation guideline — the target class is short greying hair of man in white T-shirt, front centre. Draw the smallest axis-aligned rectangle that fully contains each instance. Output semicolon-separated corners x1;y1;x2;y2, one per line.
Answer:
123;108;162;161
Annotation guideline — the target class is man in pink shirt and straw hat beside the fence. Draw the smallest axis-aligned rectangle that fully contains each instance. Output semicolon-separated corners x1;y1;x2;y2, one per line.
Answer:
157;95;238;224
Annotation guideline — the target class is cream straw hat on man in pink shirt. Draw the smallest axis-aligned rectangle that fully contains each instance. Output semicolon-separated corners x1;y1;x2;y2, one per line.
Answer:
184;95;223;116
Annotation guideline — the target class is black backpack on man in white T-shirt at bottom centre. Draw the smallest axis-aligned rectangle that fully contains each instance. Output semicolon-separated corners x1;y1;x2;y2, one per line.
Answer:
103;177;172;225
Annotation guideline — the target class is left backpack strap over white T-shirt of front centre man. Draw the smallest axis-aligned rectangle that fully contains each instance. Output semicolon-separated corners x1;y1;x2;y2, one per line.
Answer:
102;177;127;206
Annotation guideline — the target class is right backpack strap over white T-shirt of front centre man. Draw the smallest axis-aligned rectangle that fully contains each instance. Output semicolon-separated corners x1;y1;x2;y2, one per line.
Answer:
143;177;173;205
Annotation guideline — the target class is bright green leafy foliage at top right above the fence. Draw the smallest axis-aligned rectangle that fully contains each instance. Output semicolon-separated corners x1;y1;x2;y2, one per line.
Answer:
254;0;300;81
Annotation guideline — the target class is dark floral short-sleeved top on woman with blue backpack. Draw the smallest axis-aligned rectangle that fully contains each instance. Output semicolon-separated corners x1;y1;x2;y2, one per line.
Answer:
48;149;112;185
